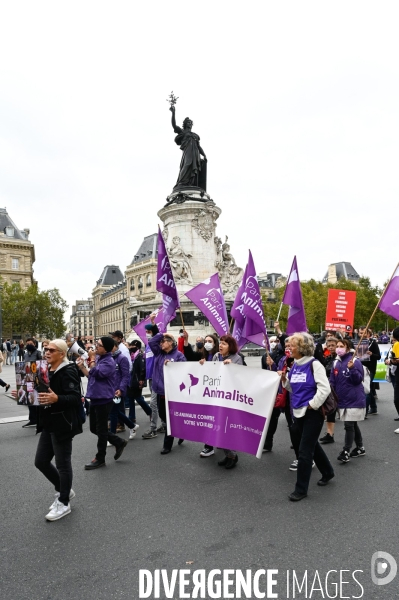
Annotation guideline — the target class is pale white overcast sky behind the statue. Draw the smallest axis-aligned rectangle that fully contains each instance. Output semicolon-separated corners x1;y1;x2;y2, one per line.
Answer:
0;0;399;318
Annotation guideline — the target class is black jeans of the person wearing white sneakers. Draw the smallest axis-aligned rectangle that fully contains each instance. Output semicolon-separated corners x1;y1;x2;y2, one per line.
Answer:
35;430;72;506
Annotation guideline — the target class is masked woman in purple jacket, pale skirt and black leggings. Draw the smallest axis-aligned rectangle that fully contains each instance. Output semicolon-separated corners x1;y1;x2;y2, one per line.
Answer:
330;339;366;463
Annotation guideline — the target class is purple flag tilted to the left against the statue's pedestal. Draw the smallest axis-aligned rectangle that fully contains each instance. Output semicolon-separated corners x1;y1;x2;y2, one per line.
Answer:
186;273;229;335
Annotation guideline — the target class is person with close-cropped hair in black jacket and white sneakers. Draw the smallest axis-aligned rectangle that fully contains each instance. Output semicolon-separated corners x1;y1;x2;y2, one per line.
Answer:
35;340;82;521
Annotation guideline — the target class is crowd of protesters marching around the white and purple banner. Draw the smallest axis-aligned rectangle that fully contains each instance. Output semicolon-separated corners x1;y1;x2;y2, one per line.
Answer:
7;318;399;521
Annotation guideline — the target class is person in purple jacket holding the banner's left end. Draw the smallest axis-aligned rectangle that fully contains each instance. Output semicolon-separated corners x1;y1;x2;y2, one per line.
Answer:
148;315;186;454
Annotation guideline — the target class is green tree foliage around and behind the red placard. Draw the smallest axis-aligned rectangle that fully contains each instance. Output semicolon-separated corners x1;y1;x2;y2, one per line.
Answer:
262;277;397;333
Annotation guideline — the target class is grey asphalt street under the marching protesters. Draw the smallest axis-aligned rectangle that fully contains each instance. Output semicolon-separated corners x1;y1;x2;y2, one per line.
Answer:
0;359;399;600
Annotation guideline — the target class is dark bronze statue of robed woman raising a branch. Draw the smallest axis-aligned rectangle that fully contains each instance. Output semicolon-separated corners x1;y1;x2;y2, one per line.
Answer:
169;105;207;191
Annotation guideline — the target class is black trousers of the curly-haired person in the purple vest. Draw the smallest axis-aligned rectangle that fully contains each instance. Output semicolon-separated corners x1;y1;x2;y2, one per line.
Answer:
291;408;334;494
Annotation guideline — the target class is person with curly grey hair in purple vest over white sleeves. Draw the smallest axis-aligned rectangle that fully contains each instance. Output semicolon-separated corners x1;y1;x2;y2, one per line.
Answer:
281;332;334;502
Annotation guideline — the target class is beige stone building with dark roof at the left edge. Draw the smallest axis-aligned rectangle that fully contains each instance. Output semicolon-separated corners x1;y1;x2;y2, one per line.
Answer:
0;208;35;289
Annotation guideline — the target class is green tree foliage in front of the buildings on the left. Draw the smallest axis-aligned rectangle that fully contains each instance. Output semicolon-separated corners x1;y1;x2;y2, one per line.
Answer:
1;283;68;339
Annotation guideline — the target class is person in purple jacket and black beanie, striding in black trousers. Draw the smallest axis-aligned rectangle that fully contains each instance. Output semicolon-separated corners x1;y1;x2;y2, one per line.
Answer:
76;336;128;471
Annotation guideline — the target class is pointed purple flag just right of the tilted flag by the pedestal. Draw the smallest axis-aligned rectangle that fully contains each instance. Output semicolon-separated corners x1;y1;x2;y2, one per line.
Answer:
231;251;269;347
